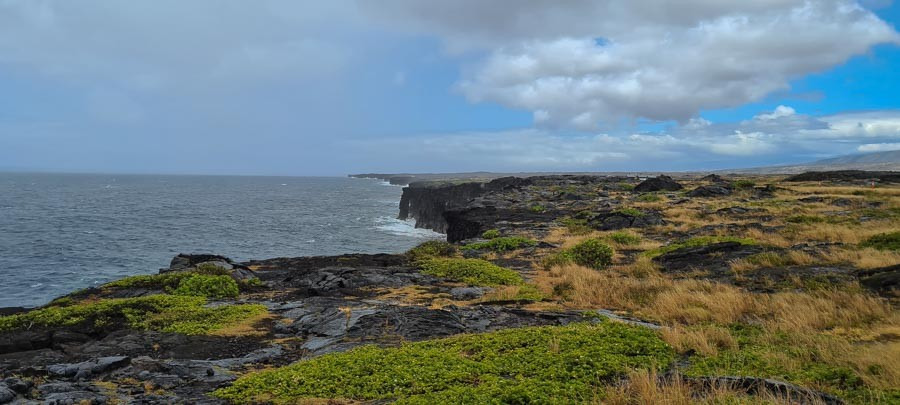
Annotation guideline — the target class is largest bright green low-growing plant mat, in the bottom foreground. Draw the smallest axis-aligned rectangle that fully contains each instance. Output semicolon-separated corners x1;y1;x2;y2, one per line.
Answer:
213;322;674;404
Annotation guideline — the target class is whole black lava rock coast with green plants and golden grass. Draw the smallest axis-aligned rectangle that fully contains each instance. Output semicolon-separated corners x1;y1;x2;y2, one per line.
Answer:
0;173;900;404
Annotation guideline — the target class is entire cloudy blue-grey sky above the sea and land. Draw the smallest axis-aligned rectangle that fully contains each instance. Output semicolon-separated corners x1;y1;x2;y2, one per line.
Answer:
0;0;900;175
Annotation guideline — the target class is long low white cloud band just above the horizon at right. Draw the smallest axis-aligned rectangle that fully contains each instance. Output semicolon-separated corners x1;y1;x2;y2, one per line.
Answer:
348;106;900;171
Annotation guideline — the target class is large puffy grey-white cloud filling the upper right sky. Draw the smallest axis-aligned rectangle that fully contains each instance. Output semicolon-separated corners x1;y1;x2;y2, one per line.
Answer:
367;0;900;130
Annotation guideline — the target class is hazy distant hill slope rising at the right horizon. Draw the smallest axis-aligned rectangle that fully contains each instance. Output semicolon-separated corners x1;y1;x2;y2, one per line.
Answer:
718;150;900;174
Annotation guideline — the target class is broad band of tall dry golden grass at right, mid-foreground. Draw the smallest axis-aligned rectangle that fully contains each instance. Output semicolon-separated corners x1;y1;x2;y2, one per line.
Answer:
535;265;893;331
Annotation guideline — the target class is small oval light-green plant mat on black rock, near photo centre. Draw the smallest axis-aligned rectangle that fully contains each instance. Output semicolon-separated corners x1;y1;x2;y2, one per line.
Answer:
419;258;524;287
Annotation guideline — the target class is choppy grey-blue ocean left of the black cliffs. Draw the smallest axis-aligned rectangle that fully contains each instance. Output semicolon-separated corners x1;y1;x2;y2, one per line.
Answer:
0;173;441;307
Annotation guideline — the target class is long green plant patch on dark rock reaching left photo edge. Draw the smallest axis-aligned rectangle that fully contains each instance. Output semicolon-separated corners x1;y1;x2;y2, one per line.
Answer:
0;295;266;335
